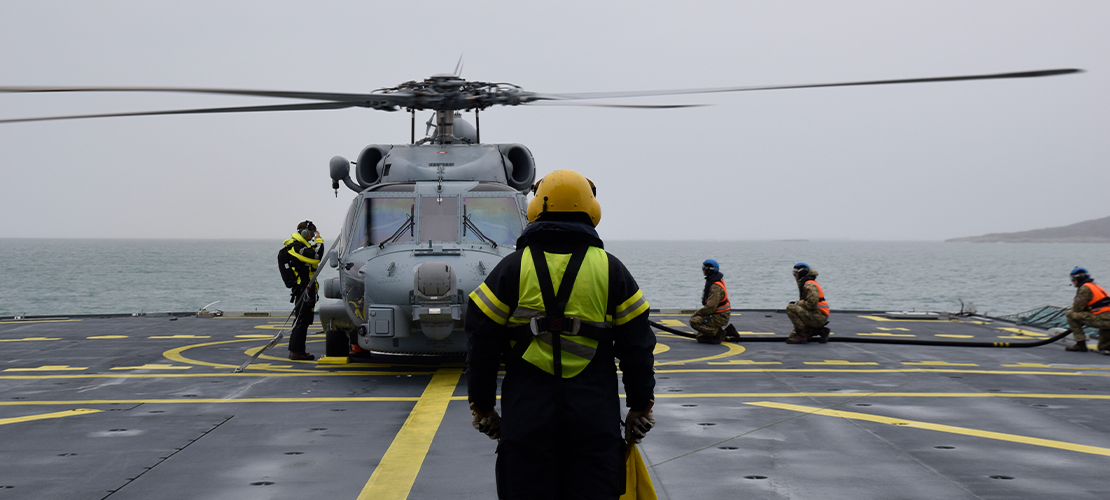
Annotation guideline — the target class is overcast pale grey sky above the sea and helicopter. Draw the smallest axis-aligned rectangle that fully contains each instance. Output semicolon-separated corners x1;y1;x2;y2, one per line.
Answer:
0;0;1110;240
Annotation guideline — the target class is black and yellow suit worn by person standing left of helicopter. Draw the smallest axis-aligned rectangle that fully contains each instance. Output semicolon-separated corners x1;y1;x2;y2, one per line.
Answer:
282;232;324;352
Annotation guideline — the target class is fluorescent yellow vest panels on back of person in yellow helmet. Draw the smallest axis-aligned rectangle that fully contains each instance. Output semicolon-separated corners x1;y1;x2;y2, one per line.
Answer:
508;247;612;379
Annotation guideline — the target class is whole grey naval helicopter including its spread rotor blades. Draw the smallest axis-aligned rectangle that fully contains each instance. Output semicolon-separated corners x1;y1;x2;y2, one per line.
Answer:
0;68;1082;357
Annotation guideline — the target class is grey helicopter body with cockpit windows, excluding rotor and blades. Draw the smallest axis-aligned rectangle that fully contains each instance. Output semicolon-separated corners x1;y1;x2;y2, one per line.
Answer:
319;144;534;356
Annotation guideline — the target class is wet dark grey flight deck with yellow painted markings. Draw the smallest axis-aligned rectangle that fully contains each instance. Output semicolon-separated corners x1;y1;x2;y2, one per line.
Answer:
0;311;1110;500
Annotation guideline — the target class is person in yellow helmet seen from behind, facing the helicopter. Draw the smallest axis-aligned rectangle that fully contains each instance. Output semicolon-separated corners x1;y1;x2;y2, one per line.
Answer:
465;170;655;500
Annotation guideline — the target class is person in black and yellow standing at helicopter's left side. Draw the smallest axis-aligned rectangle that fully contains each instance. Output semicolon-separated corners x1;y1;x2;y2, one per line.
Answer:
278;220;324;361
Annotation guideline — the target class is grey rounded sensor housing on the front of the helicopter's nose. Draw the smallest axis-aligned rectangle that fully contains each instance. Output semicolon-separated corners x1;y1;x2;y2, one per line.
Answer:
413;261;462;340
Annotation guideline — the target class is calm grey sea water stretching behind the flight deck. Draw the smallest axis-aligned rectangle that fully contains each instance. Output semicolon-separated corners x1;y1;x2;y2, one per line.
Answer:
0;239;1110;317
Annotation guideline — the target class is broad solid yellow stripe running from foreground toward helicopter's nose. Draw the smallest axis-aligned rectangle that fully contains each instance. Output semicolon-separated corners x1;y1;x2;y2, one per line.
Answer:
359;369;463;500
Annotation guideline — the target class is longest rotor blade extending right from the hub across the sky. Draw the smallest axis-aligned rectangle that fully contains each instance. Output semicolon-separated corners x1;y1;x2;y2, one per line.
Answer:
528;68;1083;101
